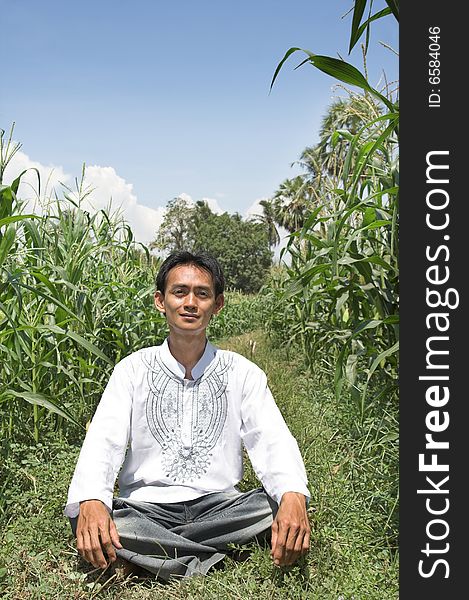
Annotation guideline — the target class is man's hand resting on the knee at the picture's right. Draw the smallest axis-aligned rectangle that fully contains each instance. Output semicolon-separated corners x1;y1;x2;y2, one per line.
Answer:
270;492;310;567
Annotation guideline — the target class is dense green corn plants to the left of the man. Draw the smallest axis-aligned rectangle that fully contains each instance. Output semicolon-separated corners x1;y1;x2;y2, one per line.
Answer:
0;134;164;442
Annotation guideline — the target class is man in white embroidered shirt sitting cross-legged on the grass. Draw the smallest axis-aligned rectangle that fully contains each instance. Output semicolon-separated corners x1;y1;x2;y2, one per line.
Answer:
65;252;310;580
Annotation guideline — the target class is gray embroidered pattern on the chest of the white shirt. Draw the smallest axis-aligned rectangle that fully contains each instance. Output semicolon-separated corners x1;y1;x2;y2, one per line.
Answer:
143;353;232;483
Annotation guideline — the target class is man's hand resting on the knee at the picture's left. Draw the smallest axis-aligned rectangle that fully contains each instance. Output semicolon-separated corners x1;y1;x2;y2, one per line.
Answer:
77;500;122;569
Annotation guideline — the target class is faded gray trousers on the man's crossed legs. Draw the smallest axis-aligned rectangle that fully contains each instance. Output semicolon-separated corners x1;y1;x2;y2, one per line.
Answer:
72;488;278;581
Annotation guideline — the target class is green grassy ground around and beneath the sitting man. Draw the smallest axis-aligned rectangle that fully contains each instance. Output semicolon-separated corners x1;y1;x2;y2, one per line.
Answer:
0;334;398;600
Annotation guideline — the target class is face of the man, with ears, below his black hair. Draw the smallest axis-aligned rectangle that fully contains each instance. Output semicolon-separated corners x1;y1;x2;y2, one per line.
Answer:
155;265;224;333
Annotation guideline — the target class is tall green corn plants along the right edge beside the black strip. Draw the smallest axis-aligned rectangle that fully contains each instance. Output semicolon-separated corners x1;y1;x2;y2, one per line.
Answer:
271;1;399;418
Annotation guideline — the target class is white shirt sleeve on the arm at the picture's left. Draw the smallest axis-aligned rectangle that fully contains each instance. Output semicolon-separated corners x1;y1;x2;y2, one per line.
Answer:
65;359;133;517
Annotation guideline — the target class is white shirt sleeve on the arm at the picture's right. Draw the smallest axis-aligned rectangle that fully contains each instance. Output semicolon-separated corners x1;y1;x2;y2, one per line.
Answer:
241;365;310;503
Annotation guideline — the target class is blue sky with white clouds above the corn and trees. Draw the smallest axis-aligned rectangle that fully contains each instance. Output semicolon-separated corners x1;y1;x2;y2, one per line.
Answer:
0;0;398;244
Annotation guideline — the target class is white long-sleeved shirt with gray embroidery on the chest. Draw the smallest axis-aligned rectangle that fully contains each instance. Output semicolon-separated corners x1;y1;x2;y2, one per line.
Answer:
65;340;309;517
